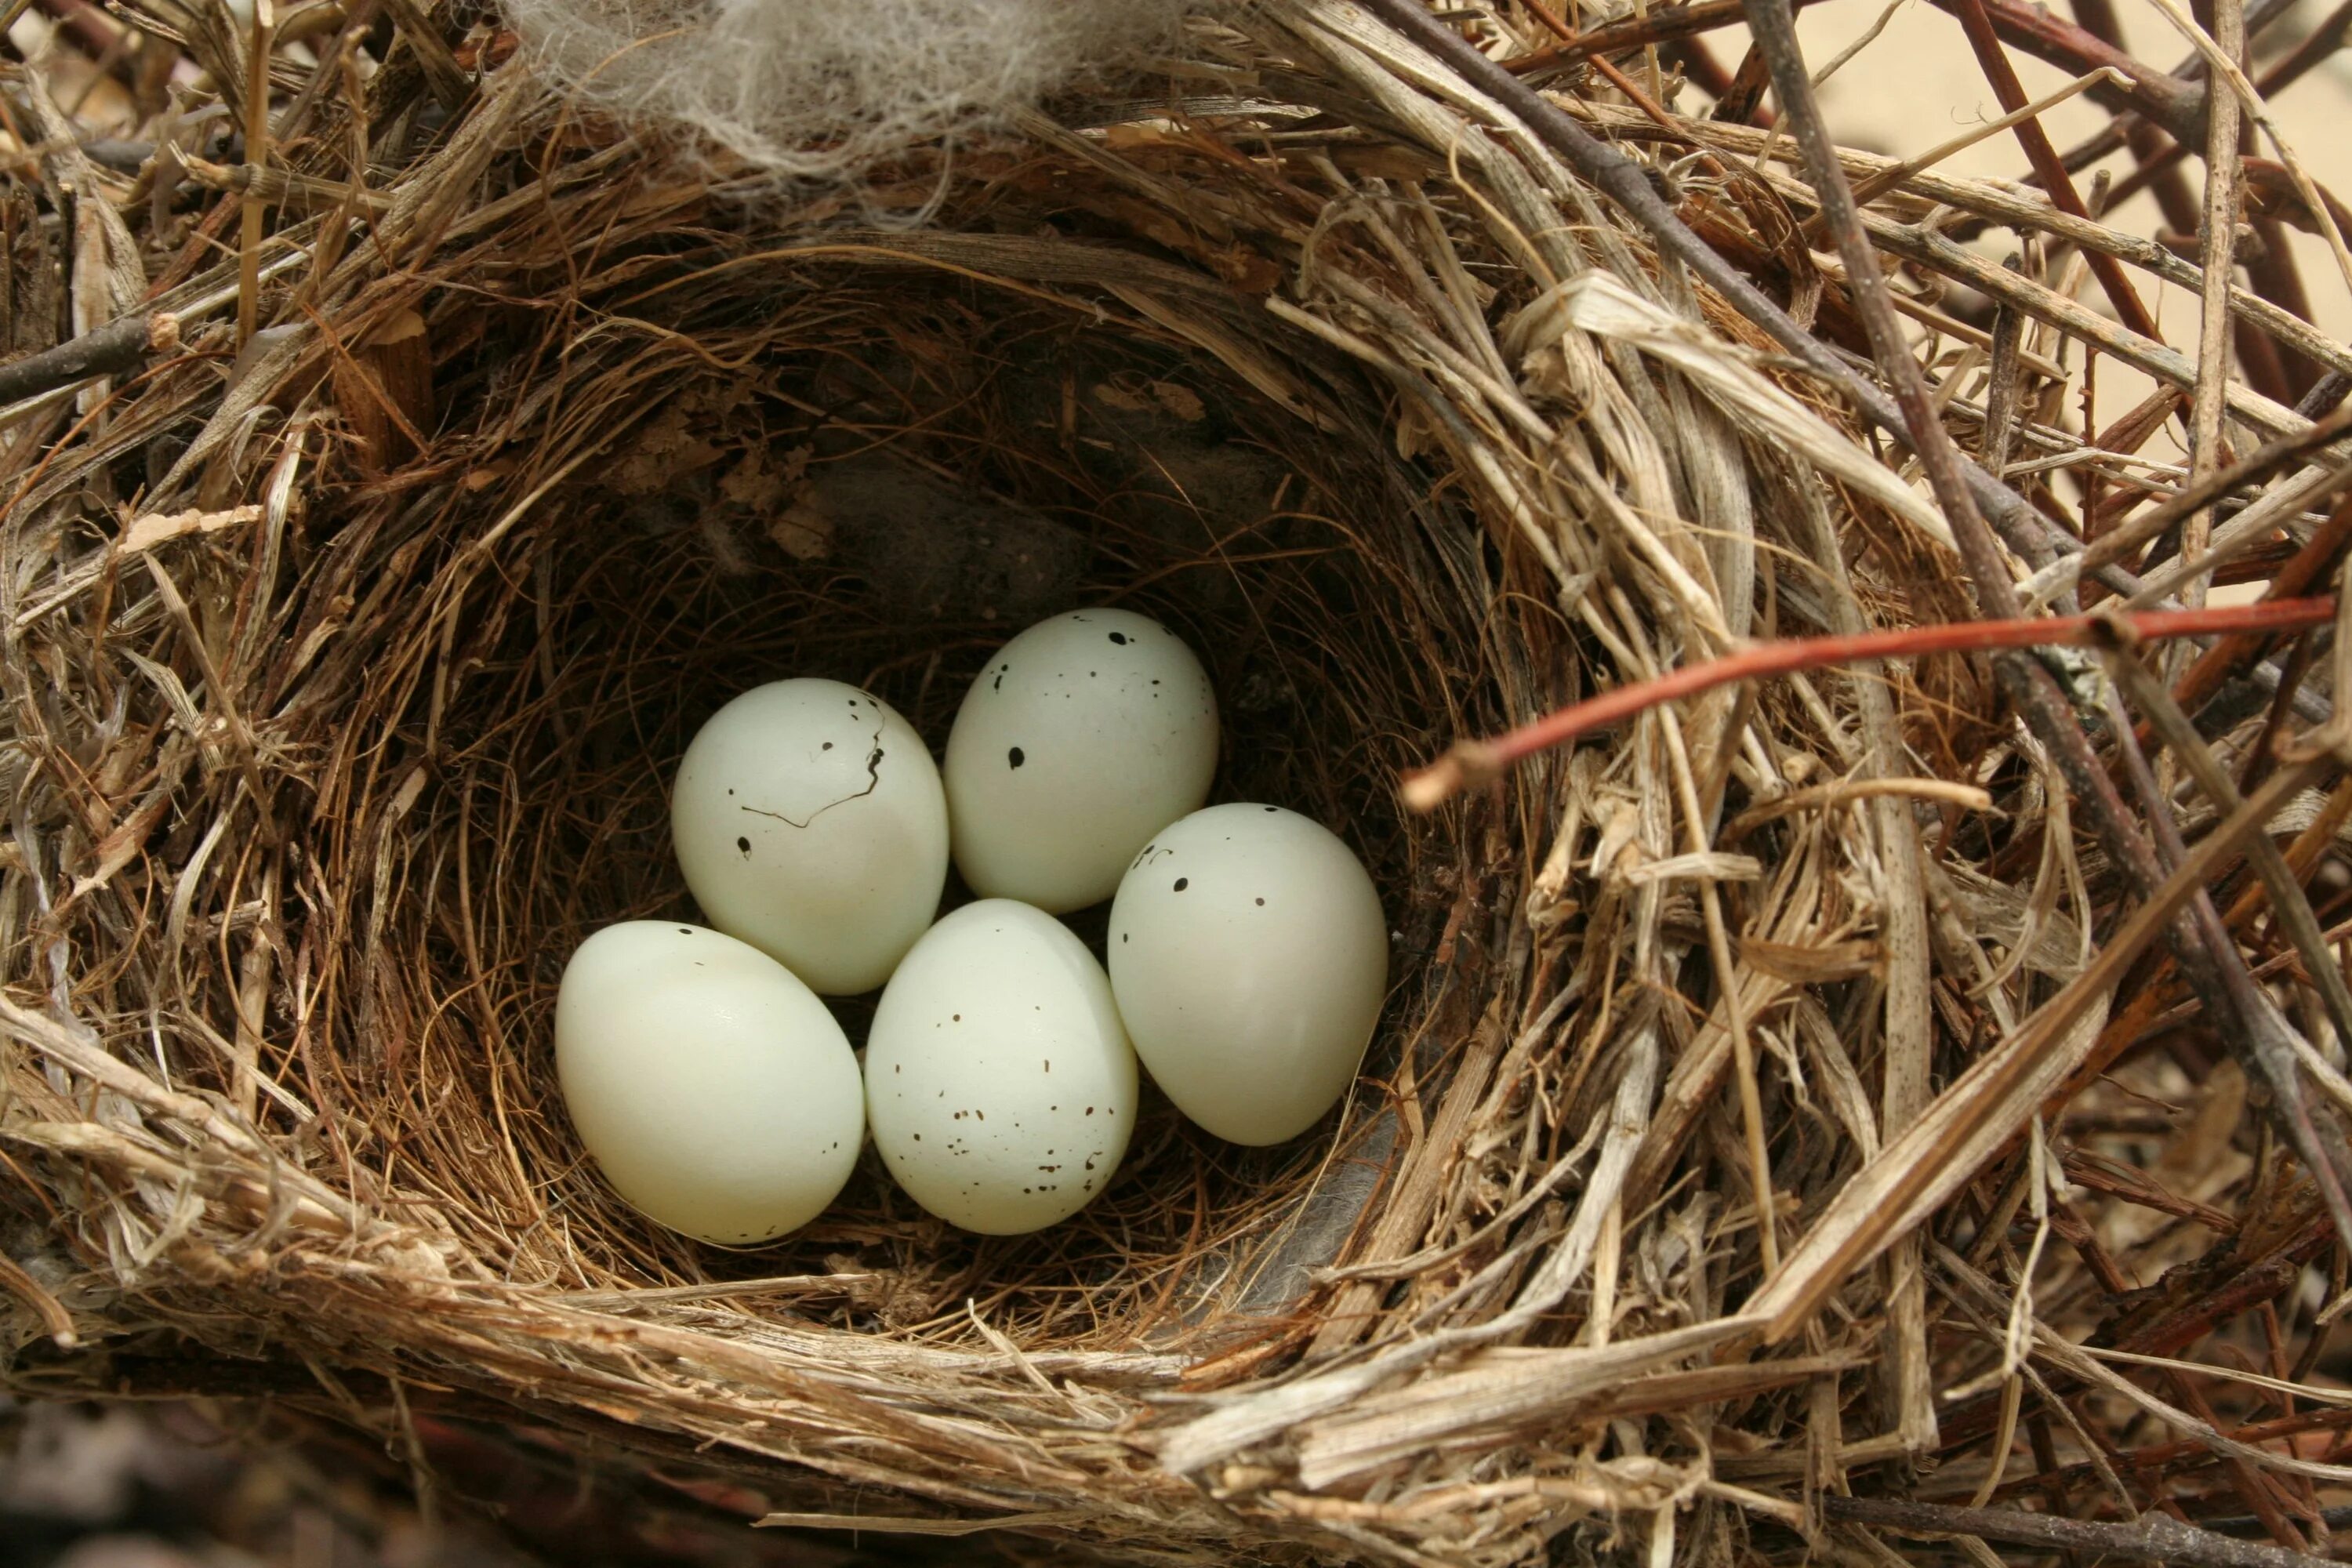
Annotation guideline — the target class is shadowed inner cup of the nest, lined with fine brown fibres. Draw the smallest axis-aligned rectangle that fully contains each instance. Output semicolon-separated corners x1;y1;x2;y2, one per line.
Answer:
388;260;1472;1349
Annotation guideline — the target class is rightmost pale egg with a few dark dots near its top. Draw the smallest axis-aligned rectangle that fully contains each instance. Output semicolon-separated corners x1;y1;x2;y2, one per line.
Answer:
1110;804;1388;1142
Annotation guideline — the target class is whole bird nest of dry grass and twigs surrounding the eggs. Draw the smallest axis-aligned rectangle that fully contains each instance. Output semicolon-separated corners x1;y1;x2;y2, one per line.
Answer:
13;0;2352;1563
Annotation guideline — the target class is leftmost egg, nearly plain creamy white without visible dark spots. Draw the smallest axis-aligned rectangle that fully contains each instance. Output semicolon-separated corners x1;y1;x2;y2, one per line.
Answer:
555;919;866;1243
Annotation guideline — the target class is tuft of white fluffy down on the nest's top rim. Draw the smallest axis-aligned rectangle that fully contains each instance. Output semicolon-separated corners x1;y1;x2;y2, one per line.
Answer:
506;0;1188;181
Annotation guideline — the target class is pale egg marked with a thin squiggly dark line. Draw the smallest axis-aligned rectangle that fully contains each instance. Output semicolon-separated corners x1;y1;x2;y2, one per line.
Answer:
670;680;948;996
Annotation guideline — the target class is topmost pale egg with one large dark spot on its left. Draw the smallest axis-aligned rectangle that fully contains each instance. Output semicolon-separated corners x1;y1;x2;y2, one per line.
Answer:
946;609;1216;914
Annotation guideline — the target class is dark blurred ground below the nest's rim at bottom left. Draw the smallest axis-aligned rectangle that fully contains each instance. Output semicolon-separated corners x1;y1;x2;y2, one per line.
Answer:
0;1399;974;1568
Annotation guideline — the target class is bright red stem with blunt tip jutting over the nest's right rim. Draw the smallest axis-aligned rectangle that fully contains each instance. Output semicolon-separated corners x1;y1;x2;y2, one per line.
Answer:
1402;600;2336;811
